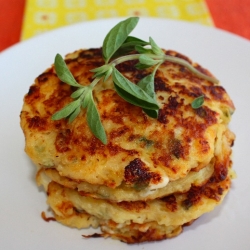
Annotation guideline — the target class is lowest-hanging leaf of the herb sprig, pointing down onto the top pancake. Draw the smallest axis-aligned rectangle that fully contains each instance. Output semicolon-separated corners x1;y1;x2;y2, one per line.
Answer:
85;91;107;144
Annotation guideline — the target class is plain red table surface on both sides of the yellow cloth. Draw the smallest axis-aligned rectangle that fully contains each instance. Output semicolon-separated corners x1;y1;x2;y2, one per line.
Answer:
0;0;250;51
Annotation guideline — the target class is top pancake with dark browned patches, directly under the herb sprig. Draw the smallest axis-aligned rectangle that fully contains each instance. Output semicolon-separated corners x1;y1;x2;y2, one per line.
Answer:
21;49;234;189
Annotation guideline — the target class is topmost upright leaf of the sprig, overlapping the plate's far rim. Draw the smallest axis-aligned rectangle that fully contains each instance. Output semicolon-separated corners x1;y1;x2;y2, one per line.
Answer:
102;17;139;63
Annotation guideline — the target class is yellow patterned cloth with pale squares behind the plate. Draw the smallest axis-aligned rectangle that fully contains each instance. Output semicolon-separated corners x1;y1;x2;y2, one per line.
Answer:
22;0;213;39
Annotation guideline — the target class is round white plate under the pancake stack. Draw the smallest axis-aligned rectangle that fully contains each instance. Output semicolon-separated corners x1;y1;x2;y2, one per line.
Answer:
0;18;250;250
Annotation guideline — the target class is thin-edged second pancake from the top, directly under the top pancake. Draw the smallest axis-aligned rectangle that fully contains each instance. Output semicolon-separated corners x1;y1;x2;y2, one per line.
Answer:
37;161;214;202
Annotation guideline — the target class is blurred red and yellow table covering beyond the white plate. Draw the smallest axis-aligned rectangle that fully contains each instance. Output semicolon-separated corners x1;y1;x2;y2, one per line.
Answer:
0;0;250;52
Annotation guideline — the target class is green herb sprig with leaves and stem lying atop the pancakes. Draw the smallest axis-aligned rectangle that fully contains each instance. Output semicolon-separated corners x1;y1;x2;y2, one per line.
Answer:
52;17;218;144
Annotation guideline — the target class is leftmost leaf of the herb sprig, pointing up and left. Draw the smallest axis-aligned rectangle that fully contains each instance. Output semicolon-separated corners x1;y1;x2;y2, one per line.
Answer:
55;54;82;87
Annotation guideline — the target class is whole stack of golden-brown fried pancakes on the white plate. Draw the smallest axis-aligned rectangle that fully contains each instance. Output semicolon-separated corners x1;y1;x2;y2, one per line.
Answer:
21;49;234;243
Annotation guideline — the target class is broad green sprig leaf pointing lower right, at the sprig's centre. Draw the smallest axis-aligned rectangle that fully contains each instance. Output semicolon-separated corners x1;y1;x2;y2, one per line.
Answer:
112;68;159;110
